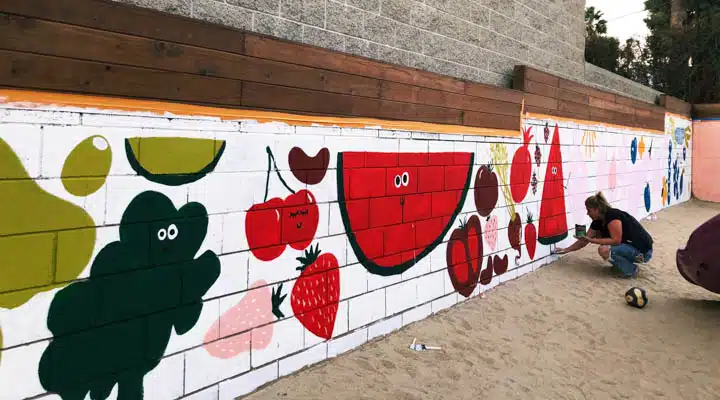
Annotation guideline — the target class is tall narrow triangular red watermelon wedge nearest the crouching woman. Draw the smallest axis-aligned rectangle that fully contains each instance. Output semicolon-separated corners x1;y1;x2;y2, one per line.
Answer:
538;124;568;245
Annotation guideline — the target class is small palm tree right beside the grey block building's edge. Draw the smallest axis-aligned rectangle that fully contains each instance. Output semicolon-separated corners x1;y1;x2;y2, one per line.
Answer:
585;7;620;72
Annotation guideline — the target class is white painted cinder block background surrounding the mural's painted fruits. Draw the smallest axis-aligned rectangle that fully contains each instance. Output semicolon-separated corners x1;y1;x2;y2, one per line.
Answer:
0;105;692;400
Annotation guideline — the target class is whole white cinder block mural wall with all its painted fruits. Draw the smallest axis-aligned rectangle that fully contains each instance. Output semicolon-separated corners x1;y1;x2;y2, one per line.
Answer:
0;94;692;400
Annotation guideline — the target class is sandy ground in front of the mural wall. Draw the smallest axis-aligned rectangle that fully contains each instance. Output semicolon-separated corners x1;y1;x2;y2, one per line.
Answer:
246;200;720;400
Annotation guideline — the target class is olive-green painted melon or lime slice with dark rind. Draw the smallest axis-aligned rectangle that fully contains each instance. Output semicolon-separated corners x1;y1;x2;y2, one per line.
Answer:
125;137;225;186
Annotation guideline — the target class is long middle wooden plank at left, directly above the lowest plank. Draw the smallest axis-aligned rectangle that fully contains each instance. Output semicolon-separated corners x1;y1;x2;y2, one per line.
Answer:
0;16;380;97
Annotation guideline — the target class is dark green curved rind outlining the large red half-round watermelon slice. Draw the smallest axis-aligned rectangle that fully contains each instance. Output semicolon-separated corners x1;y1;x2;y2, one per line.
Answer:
336;152;475;276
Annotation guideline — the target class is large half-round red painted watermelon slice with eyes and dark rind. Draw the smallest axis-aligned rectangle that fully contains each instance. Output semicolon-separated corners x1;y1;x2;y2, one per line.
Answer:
337;152;475;276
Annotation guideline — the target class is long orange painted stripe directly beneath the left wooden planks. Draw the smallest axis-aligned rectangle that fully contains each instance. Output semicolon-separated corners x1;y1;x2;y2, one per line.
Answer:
0;89;520;137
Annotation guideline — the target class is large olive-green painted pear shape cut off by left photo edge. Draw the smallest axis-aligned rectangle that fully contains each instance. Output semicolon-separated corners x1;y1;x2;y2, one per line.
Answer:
0;139;96;308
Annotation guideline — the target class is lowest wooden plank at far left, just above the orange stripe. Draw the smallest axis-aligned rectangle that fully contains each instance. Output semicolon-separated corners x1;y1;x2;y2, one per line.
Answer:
0;50;242;107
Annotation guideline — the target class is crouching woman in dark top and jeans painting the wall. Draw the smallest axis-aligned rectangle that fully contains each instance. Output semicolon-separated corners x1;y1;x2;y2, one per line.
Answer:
555;192;653;277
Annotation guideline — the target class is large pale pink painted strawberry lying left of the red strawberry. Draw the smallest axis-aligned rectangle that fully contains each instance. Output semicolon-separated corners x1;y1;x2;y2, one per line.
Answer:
204;280;285;358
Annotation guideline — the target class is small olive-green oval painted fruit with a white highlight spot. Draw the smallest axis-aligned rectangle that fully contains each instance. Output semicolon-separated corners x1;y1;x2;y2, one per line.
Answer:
62;135;112;197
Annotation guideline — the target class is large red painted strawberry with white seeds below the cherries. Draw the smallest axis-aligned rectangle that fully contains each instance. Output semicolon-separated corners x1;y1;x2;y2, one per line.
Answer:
290;245;340;339
